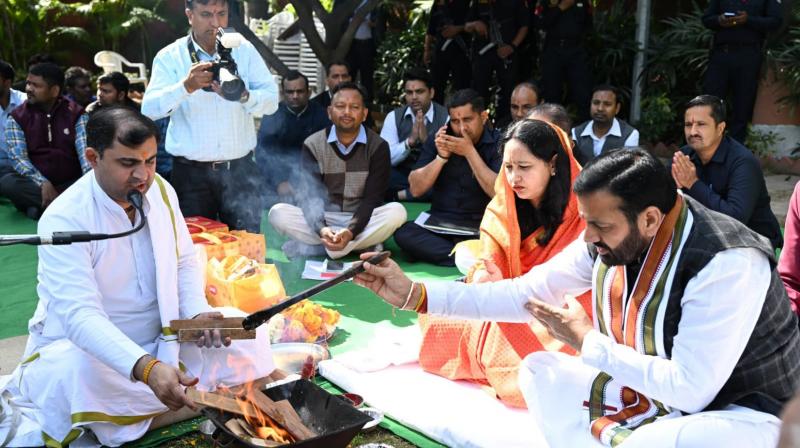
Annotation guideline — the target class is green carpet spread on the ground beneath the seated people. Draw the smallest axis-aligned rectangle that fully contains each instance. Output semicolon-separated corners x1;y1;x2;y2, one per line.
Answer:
0;198;460;447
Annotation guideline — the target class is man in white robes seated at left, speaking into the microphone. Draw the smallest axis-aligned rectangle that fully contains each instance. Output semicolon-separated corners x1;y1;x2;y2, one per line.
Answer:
0;108;273;446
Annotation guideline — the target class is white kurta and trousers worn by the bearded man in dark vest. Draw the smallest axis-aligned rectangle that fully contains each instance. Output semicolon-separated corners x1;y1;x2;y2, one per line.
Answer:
425;239;780;447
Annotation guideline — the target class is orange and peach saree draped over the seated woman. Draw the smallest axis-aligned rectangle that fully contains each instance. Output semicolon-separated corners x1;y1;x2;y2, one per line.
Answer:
419;121;591;407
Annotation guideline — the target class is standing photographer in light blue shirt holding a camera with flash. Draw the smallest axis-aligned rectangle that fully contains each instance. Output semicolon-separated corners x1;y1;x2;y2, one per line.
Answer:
142;0;278;233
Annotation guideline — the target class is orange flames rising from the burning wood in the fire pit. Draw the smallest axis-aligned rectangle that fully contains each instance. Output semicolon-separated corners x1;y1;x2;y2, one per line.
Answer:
225;355;295;443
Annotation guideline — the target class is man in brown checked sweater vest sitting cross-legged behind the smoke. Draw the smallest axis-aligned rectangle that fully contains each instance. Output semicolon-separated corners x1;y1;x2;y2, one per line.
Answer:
269;82;406;258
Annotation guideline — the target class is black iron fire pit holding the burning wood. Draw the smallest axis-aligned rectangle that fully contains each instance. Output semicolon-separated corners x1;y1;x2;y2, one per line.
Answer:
202;380;371;448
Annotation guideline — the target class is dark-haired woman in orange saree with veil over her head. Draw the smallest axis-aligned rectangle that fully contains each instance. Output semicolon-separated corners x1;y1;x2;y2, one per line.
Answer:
419;119;591;407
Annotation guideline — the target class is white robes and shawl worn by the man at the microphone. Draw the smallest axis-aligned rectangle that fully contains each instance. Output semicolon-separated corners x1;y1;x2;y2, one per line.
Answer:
0;172;273;446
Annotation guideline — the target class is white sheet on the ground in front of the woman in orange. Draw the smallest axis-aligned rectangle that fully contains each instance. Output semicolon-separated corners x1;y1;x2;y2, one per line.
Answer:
319;325;547;448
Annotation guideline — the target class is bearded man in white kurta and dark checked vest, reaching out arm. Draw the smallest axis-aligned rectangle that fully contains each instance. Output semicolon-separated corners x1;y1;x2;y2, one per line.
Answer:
356;150;800;448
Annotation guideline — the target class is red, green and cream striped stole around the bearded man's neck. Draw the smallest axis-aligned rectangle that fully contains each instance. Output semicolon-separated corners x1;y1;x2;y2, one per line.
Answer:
589;195;691;446
